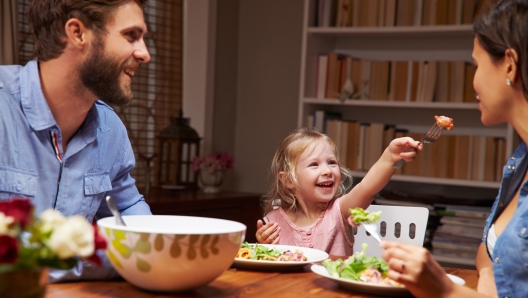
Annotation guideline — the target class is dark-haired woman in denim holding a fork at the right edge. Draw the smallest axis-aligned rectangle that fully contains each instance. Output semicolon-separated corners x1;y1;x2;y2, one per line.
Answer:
381;0;528;297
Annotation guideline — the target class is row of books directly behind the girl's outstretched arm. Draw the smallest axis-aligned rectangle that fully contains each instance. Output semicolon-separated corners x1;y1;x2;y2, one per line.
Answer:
308;111;506;181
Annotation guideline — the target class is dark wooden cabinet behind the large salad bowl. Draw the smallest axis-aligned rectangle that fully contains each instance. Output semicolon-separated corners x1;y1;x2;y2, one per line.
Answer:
146;188;262;243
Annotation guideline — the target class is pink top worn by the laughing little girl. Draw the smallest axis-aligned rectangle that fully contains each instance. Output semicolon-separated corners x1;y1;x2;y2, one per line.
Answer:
264;198;354;256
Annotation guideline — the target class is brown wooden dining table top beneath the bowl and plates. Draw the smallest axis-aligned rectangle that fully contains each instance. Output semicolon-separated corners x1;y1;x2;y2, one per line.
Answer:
45;256;478;298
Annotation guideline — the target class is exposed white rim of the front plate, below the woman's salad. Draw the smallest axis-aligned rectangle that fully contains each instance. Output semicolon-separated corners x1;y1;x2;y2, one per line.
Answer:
311;264;466;296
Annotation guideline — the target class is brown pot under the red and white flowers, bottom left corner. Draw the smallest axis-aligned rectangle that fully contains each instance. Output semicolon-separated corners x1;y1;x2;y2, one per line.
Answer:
0;268;49;298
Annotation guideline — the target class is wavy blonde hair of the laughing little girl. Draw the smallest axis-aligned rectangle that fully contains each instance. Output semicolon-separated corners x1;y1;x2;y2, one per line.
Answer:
261;128;352;214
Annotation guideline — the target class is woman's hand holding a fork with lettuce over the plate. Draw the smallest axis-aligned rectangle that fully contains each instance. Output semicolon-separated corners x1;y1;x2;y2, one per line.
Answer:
380;241;456;297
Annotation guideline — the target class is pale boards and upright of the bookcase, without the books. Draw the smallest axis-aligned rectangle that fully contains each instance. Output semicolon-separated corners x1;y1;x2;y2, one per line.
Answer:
298;0;513;189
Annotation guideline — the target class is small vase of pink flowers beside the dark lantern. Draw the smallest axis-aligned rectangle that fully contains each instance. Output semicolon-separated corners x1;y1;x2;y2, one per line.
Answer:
192;151;234;193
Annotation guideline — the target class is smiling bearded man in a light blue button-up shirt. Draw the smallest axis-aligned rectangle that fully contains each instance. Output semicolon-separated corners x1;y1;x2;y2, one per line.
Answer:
0;0;151;282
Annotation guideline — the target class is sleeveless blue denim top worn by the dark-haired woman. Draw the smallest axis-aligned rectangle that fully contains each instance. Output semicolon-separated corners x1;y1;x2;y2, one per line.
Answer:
482;142;528;298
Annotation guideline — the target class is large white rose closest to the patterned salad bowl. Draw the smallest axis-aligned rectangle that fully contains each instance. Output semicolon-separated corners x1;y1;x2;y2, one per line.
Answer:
48;215;94;259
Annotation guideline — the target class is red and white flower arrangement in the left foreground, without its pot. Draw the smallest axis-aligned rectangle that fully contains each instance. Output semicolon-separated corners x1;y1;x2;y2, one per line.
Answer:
0;199;106;273
